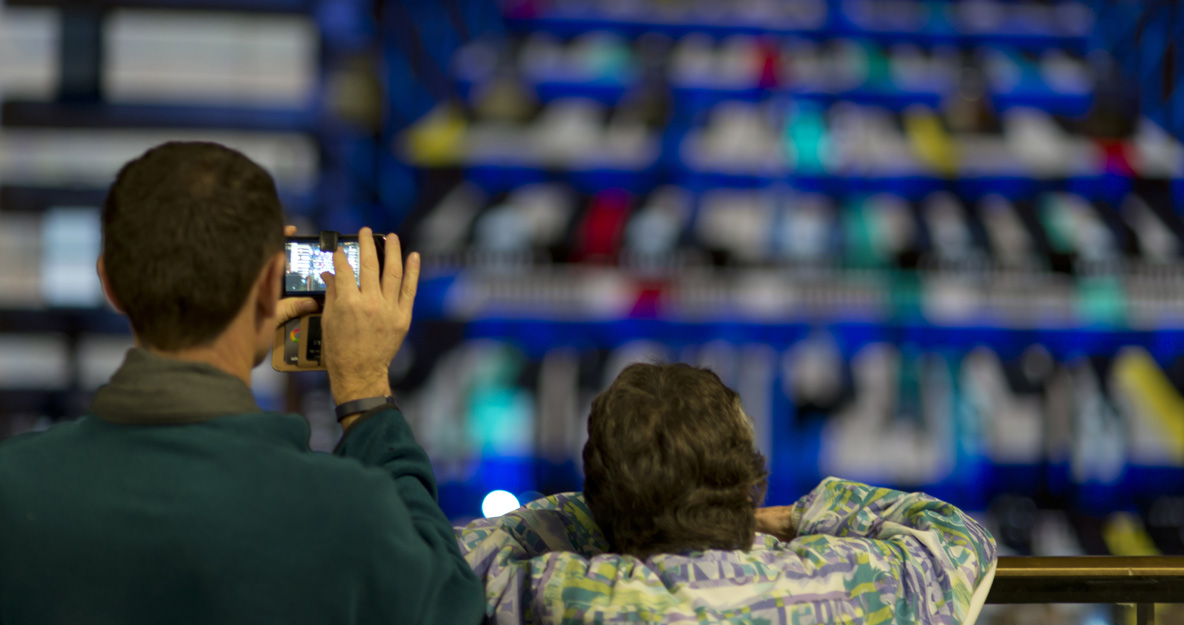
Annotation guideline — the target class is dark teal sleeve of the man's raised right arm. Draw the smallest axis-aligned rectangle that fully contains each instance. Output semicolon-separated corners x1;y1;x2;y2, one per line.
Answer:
334;407;483;624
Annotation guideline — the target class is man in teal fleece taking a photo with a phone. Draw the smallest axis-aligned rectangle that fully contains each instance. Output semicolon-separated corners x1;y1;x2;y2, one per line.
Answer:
0;143;482;625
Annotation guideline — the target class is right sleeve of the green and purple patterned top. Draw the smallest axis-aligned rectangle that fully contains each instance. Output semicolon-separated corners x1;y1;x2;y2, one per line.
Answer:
781;478;996;623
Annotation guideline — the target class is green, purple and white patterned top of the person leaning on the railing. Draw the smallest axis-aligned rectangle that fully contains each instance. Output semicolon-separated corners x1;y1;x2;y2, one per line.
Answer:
456;478;996;625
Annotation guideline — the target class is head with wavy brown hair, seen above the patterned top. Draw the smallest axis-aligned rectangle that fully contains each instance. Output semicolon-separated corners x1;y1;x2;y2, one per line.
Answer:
584;363;768;558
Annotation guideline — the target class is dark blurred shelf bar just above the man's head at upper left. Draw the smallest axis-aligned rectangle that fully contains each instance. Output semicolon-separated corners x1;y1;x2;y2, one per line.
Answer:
0;101;316;133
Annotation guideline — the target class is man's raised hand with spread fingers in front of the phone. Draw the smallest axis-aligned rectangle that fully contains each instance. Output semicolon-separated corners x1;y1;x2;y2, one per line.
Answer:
321;227;419;404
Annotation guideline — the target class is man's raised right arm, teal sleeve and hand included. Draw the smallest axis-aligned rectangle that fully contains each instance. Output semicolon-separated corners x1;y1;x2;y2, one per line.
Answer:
321;228;482;623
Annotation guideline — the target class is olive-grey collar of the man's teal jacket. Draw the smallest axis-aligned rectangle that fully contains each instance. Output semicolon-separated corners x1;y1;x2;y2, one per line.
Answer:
90;348;262;425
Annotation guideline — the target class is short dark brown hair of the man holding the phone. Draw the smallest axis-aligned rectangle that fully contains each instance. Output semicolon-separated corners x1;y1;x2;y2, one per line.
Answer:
103;142;284;350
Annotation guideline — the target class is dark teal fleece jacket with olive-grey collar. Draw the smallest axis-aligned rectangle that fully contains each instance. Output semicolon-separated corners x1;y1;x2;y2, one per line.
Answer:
0;349;484;625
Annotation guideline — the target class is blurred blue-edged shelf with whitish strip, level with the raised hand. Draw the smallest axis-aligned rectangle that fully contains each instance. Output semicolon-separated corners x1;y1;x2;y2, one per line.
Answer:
404;265;1184;340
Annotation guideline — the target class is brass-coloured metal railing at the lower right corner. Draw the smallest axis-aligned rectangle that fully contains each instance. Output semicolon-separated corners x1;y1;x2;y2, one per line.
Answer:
986;555;1184;625
